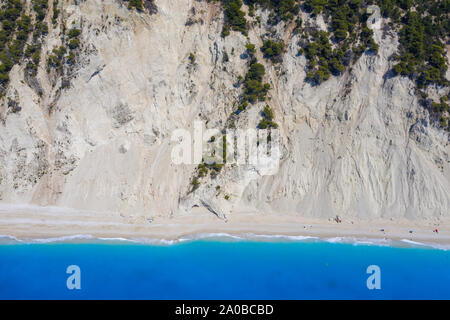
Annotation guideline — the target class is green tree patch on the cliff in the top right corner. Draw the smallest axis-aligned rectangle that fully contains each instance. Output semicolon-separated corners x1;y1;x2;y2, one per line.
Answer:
368;0;450;131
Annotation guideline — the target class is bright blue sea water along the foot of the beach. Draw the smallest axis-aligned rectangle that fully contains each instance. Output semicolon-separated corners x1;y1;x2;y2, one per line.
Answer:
0;240;450;299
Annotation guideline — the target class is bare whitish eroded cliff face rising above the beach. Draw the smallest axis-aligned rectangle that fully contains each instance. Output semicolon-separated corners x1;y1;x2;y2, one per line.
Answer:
0;0;450;221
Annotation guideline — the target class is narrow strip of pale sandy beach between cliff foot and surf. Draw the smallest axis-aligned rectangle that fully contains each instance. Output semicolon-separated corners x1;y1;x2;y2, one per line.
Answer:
0;205;450;248
